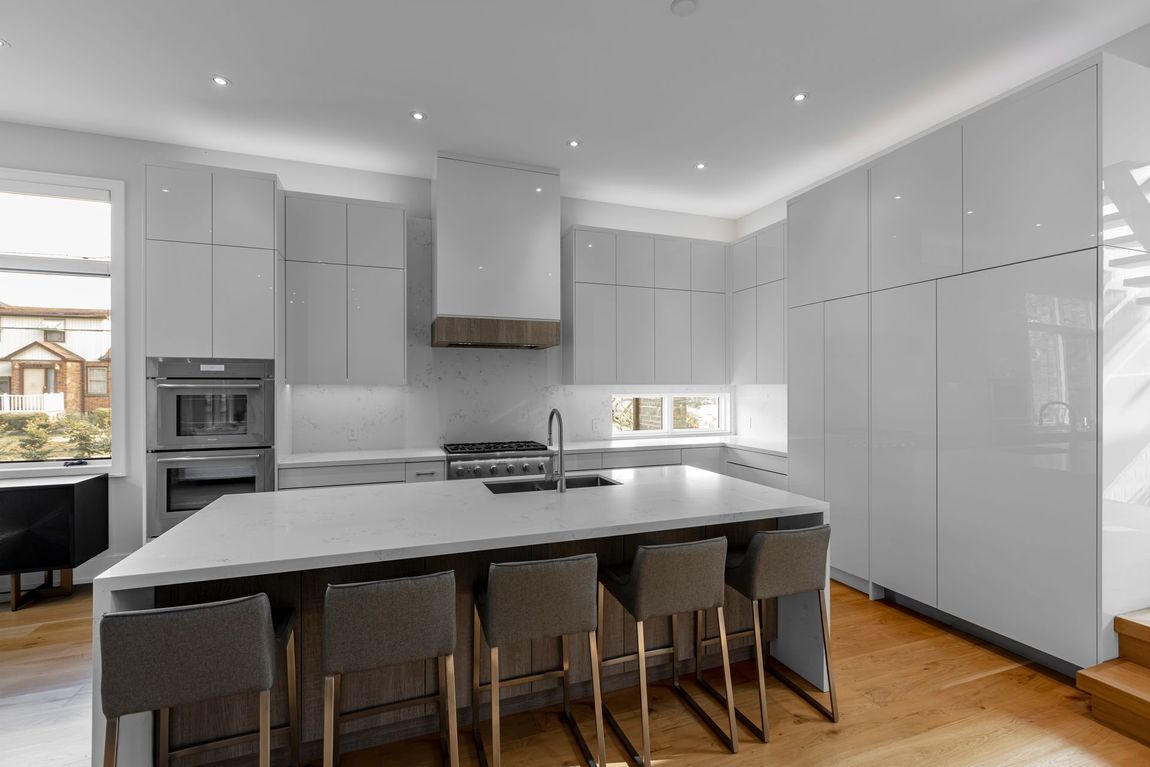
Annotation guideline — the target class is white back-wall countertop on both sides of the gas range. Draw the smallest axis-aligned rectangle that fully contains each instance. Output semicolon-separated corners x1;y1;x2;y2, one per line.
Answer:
277;435;787;468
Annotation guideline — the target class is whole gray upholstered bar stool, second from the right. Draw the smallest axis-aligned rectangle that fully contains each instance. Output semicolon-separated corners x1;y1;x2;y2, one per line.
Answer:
599;538;738;767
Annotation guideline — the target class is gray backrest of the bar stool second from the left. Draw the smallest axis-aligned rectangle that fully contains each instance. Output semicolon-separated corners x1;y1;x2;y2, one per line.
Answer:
323;570;455;674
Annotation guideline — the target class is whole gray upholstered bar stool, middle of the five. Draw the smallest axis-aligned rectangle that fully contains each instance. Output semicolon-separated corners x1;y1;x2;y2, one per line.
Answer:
472;554;606;767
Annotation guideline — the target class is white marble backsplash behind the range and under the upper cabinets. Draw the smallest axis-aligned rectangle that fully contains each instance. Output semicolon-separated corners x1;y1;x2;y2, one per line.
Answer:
288;218;787;453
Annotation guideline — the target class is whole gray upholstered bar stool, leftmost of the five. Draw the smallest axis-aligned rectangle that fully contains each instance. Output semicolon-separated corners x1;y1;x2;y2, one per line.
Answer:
100;593;285;767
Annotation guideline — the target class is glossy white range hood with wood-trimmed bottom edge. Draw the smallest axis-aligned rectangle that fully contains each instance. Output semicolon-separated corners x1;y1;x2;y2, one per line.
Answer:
431;153;560;348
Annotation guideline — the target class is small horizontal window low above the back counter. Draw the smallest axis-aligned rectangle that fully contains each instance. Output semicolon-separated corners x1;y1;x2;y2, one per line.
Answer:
611;393;727;437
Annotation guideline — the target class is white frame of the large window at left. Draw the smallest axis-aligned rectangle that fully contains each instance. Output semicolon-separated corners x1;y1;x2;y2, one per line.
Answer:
0;168;128;478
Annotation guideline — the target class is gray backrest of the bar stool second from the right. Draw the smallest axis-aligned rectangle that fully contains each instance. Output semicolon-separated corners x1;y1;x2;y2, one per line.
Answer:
627;538;727;621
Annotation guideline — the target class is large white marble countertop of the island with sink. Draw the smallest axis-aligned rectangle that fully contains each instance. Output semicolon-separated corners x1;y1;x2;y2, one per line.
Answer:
97;466;828;590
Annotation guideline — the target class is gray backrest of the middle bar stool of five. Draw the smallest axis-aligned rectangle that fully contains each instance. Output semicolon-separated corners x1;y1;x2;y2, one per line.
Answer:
481;554;599;647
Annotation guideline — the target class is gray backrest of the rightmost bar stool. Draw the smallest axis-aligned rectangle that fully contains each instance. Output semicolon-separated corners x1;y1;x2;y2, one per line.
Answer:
737;524;830;599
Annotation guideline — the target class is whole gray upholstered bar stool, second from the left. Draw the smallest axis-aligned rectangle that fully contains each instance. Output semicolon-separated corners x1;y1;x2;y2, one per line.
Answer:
323;570;459;767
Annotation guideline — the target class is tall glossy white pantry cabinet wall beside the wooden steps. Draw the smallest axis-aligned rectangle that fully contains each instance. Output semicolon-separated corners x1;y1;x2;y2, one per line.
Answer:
786;55;1150;666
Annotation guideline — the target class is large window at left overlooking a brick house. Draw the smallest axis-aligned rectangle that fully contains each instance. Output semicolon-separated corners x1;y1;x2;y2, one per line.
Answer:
0;169;123;474
